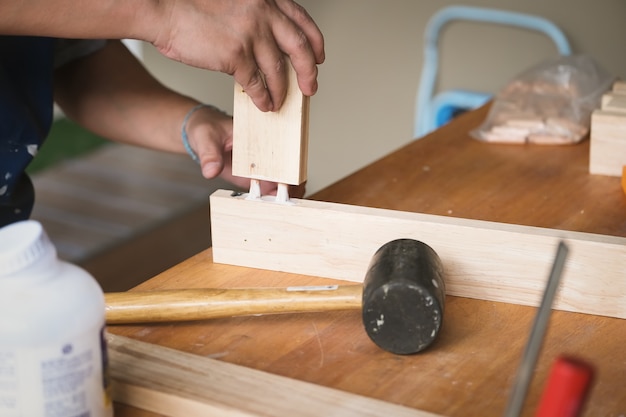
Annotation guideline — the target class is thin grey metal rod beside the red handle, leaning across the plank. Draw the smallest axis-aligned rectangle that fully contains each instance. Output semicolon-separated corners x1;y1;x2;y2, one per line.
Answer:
504;242;569;417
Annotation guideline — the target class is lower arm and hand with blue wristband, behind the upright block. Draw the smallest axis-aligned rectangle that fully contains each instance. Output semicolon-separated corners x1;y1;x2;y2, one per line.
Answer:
54;41;304;197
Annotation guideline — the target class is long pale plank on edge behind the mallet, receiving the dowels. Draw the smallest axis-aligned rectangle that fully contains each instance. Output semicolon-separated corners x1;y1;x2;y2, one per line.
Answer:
210;190;626;318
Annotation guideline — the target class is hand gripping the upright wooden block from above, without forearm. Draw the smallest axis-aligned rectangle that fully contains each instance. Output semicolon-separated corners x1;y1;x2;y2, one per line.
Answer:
152;0;324;111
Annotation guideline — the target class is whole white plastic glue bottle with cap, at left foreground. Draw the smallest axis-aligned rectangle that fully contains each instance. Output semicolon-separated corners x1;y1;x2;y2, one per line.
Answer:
0;220;113;417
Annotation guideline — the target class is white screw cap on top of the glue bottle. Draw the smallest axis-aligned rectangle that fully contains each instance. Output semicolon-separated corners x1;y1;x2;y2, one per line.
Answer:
0;220;56;276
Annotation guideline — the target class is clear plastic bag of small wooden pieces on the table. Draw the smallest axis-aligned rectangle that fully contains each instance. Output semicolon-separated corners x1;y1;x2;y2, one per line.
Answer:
471;55;615;145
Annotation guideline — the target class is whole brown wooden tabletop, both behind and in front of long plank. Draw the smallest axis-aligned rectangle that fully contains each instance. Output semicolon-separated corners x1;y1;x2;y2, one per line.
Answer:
109;108;626;417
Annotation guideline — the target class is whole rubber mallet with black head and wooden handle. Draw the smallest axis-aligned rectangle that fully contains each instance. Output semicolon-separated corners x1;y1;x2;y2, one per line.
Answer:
105;239;445;354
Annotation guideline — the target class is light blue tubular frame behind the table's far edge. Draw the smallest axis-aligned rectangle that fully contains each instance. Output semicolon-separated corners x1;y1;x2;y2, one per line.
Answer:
413;6;572;138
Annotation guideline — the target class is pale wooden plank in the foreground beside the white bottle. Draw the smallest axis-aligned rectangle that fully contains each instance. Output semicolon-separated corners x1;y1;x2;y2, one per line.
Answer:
107;334;437;417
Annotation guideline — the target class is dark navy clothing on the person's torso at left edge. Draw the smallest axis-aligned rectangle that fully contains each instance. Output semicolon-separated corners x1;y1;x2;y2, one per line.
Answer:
0;36;105;227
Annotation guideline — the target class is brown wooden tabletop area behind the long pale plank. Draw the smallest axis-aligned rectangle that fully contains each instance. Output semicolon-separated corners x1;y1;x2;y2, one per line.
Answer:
310;108;626;237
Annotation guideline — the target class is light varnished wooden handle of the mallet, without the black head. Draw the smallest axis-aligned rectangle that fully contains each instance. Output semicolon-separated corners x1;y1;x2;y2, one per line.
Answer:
105;285;363;324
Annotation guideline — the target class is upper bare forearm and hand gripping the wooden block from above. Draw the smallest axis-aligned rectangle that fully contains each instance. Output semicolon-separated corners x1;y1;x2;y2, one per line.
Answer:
0;0;324;110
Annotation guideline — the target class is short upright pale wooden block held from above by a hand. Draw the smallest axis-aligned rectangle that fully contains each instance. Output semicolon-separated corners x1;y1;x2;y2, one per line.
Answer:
233;59;309;185
